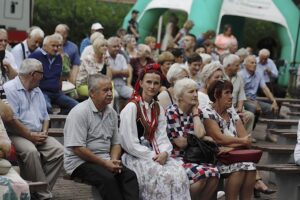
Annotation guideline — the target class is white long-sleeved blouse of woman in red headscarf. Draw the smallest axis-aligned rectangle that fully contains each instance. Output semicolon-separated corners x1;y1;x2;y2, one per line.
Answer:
120;101;173;159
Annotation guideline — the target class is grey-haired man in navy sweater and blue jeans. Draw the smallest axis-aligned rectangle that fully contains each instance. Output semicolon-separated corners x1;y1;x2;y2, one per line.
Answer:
29;34;78;114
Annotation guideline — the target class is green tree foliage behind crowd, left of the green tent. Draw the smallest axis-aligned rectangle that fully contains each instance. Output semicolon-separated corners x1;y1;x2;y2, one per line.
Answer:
33;0;132;44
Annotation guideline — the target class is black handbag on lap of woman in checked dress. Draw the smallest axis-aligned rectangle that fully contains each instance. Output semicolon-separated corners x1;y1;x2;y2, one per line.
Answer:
183;134;219;164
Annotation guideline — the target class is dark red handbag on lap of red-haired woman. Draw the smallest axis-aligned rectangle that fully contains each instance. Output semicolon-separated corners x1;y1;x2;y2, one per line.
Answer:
217;149;262;165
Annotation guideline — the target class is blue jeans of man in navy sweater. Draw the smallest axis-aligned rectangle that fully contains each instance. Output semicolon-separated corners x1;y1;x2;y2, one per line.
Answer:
43;91;78;115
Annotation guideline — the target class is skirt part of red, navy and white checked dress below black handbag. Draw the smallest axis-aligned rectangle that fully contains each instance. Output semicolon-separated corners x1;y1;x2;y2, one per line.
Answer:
175;157;220;184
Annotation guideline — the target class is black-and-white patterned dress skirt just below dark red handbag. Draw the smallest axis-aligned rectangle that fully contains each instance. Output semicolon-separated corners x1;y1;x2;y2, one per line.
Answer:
217;162;256;174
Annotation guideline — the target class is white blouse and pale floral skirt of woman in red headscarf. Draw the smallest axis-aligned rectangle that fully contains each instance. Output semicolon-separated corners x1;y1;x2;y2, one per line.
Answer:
120;101;191;200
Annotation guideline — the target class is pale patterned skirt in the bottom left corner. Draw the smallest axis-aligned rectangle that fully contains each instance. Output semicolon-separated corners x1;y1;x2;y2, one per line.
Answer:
0;168;30;200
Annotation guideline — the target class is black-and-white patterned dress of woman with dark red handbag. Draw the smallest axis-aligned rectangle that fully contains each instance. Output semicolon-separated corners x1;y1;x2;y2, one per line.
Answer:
200;104;256;174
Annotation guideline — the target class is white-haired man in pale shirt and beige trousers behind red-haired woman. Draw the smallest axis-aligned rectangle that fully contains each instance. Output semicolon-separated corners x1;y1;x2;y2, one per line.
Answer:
223;54;256;142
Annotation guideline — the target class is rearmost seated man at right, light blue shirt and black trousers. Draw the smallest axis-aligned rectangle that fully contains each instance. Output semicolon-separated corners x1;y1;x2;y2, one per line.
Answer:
256;49;286;98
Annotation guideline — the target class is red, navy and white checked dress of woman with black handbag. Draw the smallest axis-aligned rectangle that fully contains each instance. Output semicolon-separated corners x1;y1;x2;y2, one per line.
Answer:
166;104;220;184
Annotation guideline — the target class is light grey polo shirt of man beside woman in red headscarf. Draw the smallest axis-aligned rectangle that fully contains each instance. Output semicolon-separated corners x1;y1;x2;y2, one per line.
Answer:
64;98;120;174
